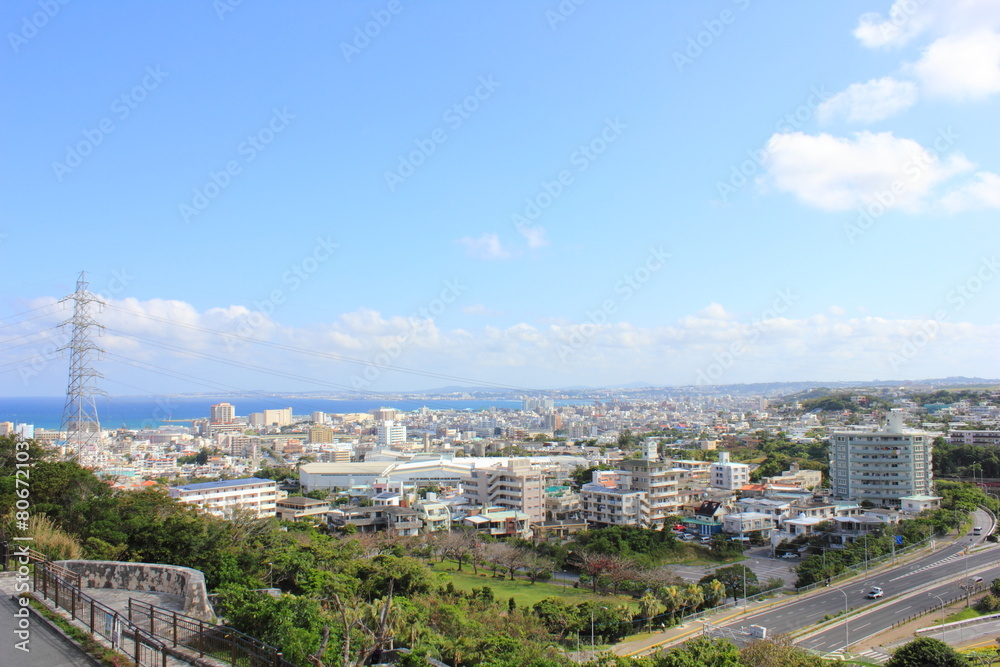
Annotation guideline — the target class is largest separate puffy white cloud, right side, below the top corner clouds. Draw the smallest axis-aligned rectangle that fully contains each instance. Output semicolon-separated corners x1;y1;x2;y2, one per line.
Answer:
758;131;973;211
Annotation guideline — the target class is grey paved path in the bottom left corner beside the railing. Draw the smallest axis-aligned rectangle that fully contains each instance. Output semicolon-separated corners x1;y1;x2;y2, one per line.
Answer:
0;573;98;667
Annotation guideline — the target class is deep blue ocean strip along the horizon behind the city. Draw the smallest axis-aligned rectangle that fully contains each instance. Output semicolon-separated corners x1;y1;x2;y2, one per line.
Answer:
0;396;592;429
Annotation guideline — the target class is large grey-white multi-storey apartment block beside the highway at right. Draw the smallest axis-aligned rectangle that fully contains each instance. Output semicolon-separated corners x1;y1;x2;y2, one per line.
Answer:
830;410;934;508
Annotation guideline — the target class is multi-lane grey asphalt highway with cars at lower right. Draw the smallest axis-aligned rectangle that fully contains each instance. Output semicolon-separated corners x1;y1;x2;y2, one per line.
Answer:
708;510;1000;653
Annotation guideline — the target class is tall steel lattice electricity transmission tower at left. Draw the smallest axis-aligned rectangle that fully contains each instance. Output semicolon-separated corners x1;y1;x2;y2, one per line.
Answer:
60;271;104;458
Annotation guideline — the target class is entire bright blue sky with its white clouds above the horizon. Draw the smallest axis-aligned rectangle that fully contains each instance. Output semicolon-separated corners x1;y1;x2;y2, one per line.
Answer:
0;0;1000;395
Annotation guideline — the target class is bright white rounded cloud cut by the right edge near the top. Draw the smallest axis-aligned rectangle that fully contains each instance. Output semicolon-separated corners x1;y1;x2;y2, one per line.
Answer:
907;30;1000;100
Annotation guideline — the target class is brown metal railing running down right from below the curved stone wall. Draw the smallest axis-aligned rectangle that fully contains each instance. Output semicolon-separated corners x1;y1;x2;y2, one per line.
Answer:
128;598;297;667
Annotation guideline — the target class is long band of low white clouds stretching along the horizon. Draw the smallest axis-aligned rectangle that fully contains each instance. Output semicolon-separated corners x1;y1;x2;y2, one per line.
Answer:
7;292;1000;393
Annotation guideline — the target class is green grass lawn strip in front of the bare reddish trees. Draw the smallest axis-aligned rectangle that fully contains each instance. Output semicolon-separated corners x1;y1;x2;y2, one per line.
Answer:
431;561;638;609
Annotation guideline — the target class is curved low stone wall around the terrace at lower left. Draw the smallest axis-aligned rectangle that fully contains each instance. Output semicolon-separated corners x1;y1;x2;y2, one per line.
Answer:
56;560;214;621
